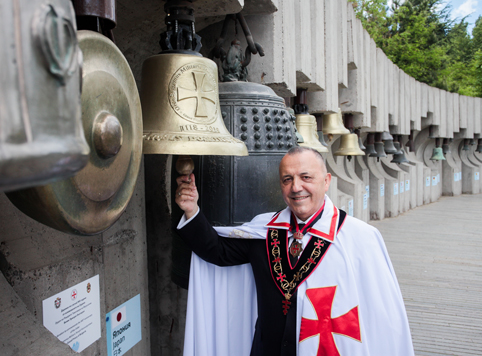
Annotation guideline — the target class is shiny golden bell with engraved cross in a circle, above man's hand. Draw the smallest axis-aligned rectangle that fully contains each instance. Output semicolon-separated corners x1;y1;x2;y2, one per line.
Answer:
141;53;248;156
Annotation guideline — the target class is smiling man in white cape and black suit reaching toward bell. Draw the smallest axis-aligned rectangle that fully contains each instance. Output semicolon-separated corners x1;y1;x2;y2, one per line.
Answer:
176;147;413;356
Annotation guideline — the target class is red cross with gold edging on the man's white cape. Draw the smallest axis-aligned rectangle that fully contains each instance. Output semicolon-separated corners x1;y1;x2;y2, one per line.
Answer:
300;287;361;356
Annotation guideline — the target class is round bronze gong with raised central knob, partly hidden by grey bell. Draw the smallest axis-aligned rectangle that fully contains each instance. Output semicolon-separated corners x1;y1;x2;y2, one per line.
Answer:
8;31;142;235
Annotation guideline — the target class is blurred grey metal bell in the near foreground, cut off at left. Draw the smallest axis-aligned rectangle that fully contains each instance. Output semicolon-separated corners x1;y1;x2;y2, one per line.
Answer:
0;0;89;191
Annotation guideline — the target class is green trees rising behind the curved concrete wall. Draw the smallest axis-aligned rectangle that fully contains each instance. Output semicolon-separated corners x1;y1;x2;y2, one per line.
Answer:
349;0;482;97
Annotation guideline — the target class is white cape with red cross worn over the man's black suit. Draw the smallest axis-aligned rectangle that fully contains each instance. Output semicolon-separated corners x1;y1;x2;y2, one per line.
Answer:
184;196;414;356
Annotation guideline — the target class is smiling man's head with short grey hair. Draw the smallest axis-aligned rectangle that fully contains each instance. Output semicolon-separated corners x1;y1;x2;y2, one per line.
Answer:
279;151;331;220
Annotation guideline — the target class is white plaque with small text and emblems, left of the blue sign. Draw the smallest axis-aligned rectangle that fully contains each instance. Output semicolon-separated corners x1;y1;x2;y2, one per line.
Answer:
42;275;100;352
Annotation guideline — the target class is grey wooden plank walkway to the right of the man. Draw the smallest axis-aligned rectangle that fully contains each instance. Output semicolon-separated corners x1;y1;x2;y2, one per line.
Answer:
370;194;482;356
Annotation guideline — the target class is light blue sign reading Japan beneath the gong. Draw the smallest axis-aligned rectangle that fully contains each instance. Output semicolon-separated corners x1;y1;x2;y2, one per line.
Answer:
105;294;142;356
